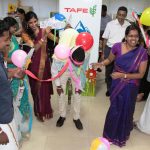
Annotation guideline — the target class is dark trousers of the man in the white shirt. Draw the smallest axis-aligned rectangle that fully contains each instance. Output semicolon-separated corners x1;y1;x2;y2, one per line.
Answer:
104;46;114;92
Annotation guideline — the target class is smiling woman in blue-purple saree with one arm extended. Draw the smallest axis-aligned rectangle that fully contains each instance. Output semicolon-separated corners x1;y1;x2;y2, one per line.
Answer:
93;25;147;147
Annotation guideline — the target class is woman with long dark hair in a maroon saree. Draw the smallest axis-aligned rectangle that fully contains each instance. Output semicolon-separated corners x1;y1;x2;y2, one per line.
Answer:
22;11;53;121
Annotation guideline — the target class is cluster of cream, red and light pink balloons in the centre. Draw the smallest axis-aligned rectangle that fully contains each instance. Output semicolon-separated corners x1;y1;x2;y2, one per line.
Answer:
54;28;94;60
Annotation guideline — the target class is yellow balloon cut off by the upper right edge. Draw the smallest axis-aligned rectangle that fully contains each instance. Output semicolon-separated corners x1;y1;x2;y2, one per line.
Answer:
140;7;150;26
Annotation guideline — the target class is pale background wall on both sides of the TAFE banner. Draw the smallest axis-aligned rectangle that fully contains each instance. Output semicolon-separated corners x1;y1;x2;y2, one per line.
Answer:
0;0;150;18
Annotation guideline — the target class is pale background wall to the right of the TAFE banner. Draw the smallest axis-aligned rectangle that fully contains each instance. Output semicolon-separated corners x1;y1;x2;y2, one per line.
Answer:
102;0;150;19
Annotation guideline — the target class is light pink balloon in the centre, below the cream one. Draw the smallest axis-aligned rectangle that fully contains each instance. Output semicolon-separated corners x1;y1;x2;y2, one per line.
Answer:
54;44;70;60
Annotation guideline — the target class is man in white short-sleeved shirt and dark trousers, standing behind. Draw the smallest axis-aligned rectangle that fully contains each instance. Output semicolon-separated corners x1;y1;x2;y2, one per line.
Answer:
102;6;130;96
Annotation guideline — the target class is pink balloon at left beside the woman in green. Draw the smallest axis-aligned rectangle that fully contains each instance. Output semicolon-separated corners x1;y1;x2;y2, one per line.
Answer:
11;50;27;68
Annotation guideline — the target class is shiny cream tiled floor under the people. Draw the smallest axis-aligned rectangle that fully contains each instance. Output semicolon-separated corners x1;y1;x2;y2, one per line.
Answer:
21;73;150;150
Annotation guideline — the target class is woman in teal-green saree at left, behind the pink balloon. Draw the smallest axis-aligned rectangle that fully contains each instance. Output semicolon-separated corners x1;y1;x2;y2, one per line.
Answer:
4;17;32;144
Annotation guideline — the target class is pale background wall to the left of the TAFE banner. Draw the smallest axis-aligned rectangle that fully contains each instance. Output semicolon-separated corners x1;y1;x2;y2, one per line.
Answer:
0;0;59;18
